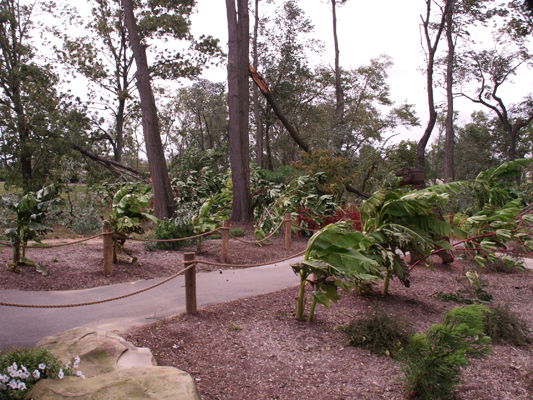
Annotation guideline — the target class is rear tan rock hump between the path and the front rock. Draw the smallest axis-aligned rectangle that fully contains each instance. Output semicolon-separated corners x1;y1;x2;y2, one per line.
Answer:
37;328;157;378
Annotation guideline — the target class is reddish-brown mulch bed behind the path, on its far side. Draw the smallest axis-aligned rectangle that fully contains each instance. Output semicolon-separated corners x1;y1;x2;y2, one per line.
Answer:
0;235;307;290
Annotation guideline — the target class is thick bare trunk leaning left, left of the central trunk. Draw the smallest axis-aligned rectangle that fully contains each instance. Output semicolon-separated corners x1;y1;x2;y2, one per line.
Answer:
121;0;174;219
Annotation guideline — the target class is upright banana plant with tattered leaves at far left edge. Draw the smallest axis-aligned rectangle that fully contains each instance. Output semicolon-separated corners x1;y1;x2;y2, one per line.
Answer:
0;185;62;276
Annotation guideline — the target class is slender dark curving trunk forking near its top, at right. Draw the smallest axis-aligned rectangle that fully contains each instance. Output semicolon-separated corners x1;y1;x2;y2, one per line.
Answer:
416;0;446;171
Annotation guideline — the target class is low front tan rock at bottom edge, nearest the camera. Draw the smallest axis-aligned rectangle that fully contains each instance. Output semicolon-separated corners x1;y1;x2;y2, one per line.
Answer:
28;367;200;400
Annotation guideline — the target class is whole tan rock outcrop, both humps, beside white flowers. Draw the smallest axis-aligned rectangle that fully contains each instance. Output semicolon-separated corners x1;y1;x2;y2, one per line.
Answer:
28;328;200;400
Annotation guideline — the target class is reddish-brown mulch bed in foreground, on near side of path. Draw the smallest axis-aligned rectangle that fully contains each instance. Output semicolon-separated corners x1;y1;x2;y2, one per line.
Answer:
127;266;533;400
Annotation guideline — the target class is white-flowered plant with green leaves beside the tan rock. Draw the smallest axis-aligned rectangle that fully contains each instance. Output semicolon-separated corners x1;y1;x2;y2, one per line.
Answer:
0;349;85;400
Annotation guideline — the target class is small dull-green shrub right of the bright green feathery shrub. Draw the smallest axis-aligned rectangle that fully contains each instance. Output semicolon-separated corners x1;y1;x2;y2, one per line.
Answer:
485;305;532;346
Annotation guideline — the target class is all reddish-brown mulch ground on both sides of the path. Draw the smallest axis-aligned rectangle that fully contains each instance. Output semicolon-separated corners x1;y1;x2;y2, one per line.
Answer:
0;230;533;400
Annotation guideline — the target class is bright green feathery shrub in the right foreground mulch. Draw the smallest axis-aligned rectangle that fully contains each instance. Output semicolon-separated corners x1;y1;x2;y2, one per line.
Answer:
399;305;490;400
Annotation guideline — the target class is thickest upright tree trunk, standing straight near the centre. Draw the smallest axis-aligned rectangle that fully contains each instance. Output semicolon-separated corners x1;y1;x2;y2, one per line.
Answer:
226;0;252;222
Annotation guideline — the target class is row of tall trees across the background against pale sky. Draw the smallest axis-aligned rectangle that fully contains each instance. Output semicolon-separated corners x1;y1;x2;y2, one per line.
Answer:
0;0;532;220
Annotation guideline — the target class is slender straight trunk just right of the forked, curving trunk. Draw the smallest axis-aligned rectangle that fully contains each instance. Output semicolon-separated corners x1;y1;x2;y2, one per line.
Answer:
444;0;455;182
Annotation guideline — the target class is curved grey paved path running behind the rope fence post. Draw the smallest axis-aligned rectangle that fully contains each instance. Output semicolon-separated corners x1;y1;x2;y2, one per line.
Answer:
0;257;303;349
